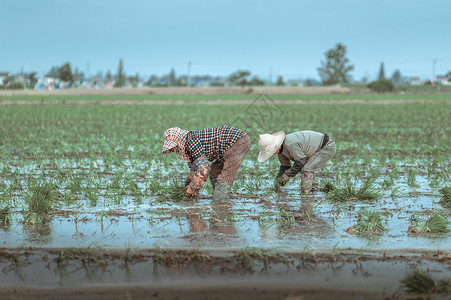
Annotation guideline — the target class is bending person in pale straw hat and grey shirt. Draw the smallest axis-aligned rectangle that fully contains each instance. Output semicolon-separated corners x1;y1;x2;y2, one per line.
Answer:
258;131;336;192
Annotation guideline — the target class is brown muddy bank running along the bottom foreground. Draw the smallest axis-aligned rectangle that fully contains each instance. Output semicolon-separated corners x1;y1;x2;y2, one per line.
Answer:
0;248;451;299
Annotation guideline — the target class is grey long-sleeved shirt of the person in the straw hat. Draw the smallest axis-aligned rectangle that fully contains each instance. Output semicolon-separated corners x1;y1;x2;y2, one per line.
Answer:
278;130;324;166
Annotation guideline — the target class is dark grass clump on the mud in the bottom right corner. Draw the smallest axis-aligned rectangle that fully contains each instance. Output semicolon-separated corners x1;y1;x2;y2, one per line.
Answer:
401;269;451;294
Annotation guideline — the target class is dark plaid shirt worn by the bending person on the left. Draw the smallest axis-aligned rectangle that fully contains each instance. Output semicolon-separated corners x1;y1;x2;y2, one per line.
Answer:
185;125;246;161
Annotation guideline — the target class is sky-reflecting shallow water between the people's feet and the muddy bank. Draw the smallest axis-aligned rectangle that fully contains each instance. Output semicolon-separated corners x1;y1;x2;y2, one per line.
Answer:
0;183;451;252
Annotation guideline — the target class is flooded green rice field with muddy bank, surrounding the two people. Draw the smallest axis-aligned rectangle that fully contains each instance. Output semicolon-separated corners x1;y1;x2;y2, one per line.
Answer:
0;103;451;299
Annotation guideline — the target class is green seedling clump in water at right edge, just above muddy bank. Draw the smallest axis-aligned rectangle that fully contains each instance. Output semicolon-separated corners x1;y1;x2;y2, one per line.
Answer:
408;211;451;233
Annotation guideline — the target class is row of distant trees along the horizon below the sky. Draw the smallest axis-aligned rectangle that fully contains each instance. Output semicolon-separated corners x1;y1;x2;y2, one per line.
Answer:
3;43;451;92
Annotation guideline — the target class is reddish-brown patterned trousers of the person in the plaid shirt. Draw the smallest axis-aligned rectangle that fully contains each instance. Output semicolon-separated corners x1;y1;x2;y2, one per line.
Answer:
218;134;251;185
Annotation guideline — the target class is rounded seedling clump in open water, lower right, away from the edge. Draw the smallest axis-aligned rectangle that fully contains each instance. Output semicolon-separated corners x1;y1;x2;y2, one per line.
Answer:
346;209;387;233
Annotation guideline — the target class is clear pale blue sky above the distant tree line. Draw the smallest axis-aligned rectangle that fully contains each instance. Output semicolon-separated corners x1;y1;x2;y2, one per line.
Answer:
0;0;451;80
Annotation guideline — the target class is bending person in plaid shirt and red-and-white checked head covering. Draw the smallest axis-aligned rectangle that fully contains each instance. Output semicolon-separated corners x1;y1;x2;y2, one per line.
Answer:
163;125;250;201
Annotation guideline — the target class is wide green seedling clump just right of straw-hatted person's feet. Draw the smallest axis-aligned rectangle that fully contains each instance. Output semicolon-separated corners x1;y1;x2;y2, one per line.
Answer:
326;179;379;202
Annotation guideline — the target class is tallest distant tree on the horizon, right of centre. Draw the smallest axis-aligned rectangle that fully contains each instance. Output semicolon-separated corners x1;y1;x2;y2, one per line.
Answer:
317;43;354;85
